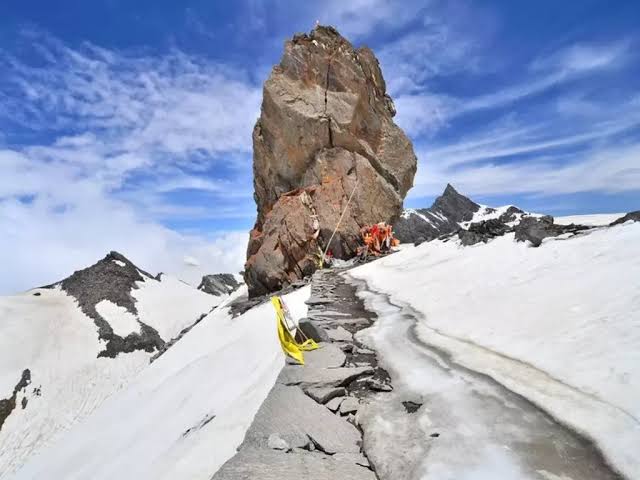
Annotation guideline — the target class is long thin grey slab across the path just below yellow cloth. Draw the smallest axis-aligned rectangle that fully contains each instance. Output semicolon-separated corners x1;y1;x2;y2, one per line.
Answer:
278;365;374;388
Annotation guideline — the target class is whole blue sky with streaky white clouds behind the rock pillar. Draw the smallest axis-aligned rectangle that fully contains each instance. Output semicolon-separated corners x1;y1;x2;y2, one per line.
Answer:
0;0;640;293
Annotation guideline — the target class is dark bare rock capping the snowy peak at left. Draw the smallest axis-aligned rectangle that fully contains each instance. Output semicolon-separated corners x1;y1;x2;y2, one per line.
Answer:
60;252;164;358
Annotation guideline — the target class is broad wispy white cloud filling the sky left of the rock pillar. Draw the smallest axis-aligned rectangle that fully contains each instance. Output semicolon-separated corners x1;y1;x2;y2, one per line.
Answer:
0;32;261;293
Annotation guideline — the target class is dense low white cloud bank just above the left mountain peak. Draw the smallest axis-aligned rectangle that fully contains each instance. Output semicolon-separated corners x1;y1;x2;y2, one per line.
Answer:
0;192;248;294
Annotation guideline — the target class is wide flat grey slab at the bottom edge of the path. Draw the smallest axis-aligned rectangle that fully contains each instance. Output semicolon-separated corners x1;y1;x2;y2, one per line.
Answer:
212;450;377;480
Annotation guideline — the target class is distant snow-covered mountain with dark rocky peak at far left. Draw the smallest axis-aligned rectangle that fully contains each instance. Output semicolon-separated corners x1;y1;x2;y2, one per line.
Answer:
0;253;226;478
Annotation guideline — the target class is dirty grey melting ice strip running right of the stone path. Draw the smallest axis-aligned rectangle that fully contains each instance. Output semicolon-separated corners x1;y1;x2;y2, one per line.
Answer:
350;283;619;480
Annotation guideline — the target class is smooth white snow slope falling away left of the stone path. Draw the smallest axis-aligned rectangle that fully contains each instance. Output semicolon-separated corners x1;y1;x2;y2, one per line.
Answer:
10;287;310;480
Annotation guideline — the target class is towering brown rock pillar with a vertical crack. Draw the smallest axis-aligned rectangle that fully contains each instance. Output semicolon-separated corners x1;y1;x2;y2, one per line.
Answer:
245;26;416;295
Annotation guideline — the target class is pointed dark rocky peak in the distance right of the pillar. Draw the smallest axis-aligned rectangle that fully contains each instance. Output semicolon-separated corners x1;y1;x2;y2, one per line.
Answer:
393;184;480;243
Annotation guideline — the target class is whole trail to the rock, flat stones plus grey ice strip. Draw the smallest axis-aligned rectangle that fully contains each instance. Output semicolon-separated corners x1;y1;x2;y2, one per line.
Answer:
213;264;622;480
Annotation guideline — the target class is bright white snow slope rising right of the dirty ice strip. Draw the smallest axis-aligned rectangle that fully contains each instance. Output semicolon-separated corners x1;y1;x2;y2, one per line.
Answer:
351;218;640;478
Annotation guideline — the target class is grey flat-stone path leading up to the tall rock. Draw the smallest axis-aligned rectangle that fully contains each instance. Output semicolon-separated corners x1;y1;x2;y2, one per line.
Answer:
213;270;392;480
